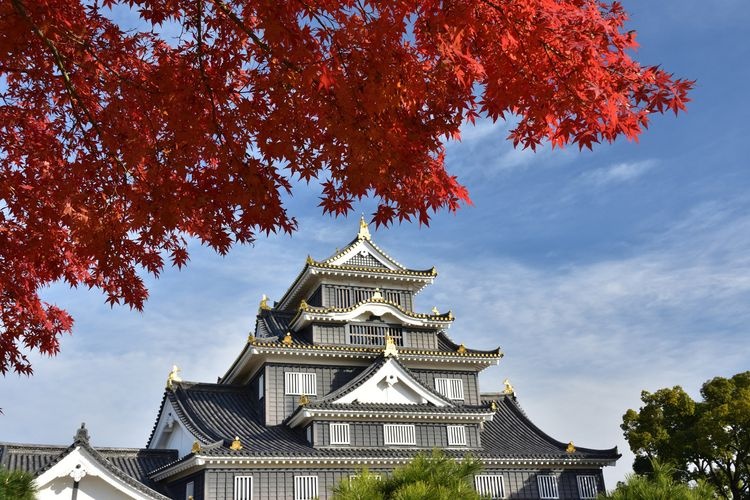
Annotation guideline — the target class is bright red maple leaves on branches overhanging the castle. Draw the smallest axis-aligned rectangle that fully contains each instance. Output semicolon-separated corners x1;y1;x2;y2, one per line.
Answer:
0;0;692;373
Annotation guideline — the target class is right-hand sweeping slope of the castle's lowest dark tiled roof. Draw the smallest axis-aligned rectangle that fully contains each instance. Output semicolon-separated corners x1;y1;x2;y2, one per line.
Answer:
480;395;620;462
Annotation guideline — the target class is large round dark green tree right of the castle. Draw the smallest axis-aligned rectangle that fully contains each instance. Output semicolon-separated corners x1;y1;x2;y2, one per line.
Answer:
621;371;750;500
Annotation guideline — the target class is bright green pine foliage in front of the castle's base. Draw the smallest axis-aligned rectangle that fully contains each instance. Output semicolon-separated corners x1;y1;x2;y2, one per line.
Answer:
333;450;482;500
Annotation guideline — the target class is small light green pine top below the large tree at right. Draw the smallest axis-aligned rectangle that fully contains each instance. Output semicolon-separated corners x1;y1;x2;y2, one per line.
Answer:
599;460;716;500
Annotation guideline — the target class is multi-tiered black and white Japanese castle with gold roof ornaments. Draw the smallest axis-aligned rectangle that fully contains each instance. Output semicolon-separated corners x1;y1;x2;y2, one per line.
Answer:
0;221;619;500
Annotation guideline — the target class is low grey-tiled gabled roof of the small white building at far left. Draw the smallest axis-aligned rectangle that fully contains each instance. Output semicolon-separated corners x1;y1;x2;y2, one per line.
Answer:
0;428;177;500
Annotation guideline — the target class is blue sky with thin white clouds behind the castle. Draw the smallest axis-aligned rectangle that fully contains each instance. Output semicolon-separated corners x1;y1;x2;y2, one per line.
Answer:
0;0;750;487
